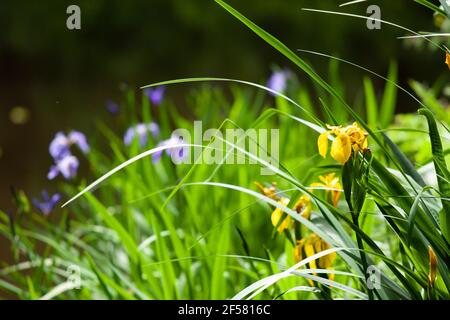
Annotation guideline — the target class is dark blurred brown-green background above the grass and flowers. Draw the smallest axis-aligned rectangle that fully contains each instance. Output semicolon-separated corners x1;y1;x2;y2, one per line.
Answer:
0;0;443;209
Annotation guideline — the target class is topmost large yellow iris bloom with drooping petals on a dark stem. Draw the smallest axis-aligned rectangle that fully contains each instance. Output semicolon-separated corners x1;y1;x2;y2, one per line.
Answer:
317;122;368;164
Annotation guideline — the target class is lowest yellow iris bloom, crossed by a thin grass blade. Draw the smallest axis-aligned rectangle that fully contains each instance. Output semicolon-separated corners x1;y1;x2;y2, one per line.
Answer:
294;233;336;280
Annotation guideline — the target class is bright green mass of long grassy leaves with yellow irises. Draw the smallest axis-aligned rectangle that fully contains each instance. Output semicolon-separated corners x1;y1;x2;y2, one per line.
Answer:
0;0;450;299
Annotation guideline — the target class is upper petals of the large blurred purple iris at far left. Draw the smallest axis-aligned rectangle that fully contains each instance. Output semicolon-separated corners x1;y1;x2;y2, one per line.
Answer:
49;130;89;161
